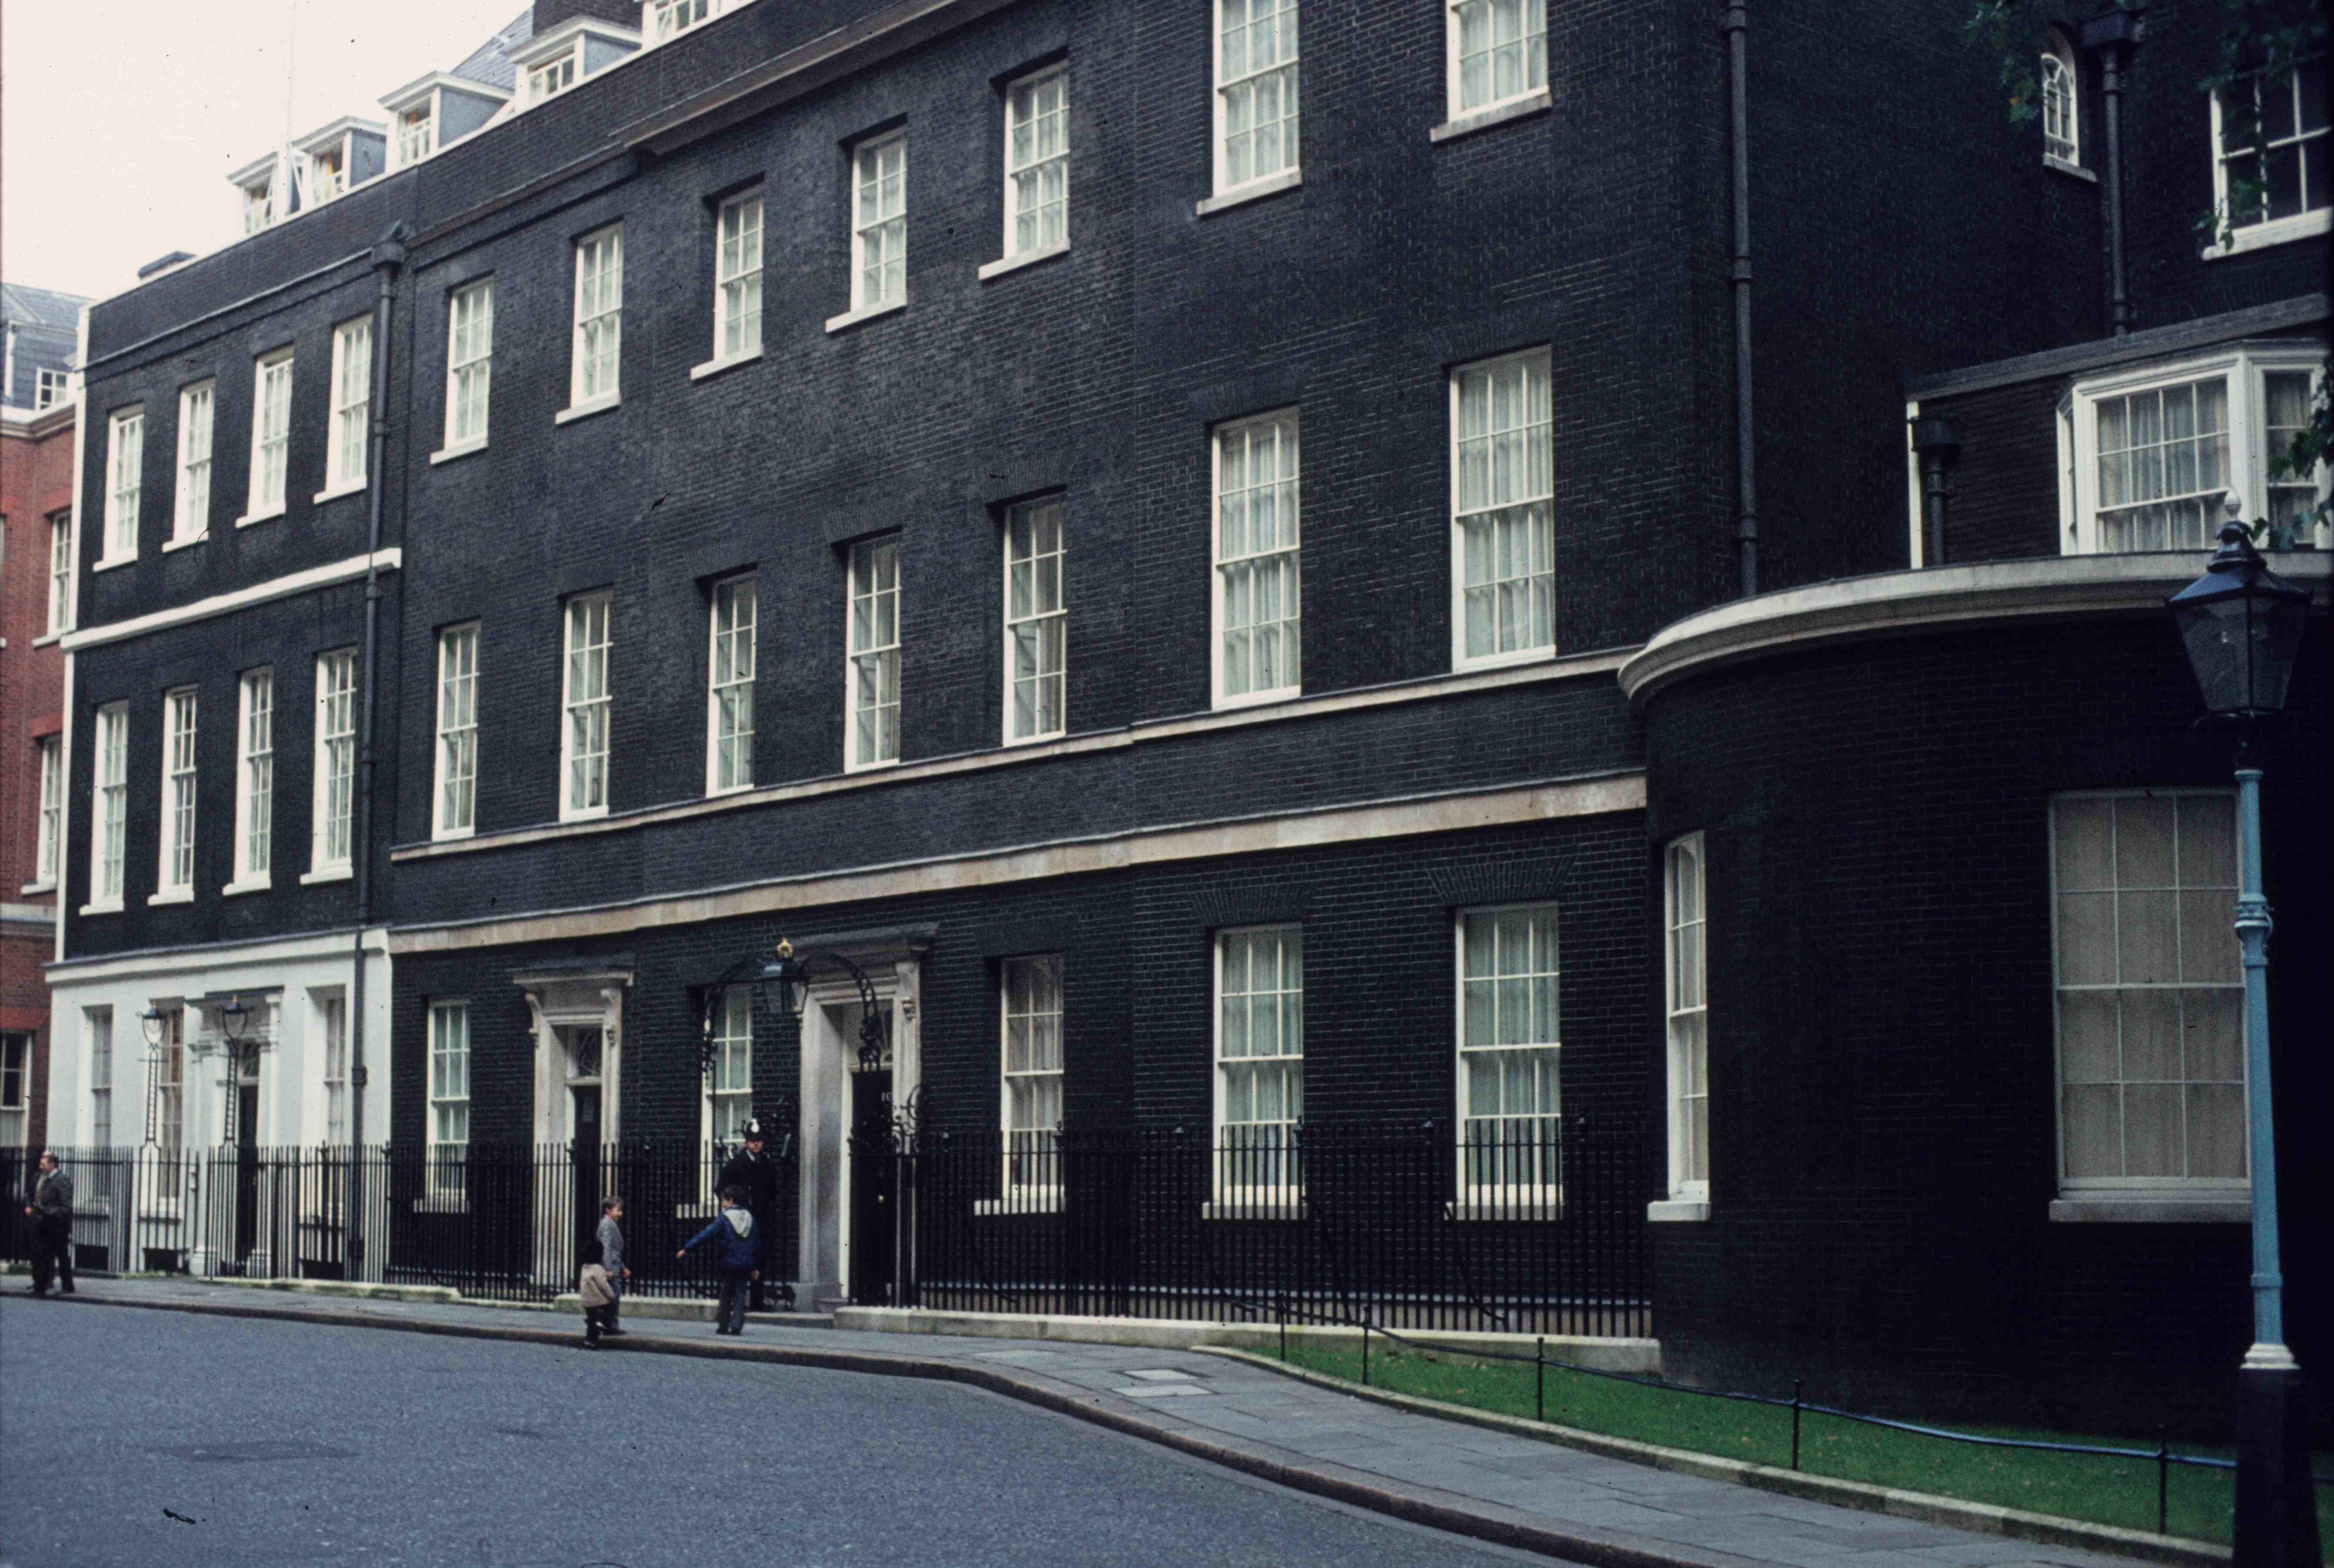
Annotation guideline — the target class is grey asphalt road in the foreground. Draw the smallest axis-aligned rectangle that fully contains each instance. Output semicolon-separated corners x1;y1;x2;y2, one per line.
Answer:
0;1300;1545;1568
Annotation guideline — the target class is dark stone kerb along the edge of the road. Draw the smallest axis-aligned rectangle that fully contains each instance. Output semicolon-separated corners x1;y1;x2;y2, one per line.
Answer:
36;1295;1771;1568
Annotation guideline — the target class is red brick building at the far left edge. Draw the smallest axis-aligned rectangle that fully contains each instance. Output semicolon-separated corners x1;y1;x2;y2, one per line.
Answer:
0;285;84;1148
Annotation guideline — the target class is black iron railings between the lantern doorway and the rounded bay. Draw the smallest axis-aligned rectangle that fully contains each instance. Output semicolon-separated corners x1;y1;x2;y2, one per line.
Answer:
852;1118;1652;1337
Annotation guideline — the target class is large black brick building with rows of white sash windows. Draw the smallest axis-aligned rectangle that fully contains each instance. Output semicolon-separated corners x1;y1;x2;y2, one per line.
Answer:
41;0;2325;1426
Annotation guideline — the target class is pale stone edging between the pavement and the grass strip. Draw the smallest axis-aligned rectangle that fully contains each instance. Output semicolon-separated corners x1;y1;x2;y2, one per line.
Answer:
1193;1330;2234;1568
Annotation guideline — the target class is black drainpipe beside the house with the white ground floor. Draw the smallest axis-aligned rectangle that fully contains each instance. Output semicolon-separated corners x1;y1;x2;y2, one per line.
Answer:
348;224;406;1278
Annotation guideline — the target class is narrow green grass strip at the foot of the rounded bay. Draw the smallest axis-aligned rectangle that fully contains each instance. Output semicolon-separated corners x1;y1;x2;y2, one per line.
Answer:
1289;1339;2334;1542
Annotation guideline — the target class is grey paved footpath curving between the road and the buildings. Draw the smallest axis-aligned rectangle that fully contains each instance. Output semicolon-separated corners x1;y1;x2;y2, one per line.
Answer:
7;1278;2175;1568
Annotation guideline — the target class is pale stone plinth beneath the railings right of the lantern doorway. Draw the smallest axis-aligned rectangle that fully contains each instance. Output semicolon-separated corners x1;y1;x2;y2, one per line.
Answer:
836;1307;1662;1377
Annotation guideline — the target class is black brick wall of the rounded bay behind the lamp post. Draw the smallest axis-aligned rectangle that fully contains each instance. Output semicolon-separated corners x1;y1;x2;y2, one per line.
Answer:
1643;616;2334;1433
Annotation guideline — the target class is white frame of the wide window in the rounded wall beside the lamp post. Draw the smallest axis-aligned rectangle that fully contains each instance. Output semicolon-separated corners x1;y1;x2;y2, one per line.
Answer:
2049;789;2252;1202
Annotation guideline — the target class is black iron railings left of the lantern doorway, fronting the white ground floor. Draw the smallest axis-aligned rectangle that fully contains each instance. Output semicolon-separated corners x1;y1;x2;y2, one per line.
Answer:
0;1143;793;1302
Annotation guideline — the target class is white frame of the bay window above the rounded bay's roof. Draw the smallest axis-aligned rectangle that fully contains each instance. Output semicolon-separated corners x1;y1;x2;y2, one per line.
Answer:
2058;338;2334;555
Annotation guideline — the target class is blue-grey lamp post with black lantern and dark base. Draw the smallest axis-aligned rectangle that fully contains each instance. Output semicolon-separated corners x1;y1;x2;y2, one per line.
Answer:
2166;509;2317;1568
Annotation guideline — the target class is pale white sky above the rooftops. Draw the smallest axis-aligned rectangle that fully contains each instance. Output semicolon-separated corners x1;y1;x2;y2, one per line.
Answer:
0;0;525;299
